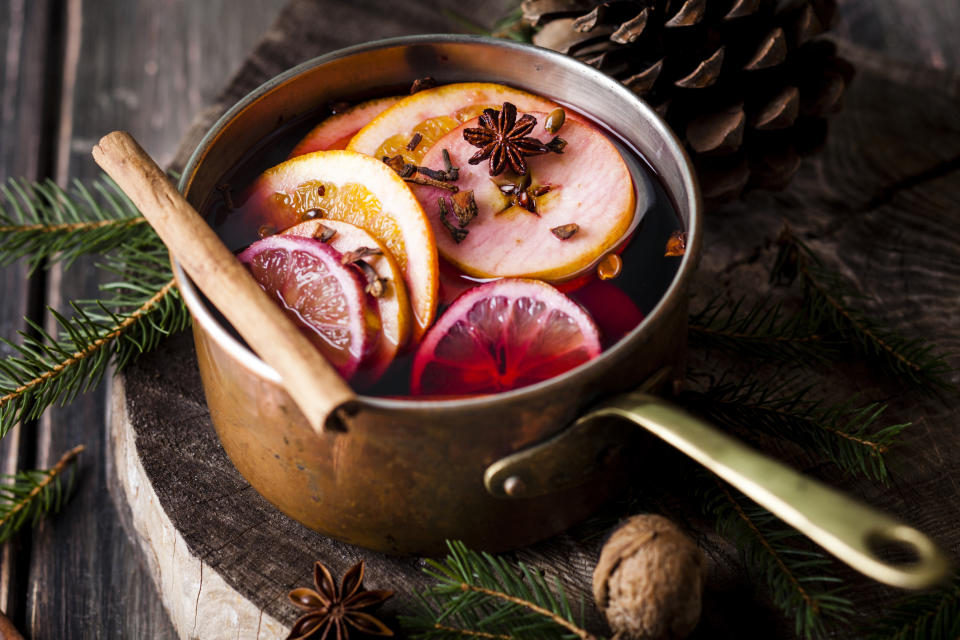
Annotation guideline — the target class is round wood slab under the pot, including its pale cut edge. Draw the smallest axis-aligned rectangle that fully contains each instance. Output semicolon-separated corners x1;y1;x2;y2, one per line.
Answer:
110;0;960;639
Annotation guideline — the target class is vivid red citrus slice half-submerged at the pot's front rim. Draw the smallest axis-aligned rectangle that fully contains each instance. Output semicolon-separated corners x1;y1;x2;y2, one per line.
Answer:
410;279;600;395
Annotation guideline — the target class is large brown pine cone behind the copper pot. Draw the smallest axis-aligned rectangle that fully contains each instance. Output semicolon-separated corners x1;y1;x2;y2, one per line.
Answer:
522;0;853;205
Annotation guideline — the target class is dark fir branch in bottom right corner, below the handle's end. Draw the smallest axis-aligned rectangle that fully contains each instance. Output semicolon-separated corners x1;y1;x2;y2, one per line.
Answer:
867;576;960;640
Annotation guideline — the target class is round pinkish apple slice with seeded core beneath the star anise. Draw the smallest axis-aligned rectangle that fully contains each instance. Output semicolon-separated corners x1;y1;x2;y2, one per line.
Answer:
413;113;643;282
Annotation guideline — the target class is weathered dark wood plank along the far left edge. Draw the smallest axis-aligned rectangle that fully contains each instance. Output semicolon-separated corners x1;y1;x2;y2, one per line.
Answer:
0;0;56;628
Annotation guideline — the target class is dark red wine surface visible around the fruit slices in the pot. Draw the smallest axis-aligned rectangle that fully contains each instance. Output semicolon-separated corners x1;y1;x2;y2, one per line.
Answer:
201;88;684;397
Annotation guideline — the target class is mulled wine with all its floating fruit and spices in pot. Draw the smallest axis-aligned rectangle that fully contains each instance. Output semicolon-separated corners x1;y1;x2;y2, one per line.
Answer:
203;83;685;397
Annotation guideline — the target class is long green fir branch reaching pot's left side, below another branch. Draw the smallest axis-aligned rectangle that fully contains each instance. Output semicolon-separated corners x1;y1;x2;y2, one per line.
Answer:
0;236;189;438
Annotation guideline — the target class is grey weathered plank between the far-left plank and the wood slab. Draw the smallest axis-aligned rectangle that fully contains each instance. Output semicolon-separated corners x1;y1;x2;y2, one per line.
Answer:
25;0;282;638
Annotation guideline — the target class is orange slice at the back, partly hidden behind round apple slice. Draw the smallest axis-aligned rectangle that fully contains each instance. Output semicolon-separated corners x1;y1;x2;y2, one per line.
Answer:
347;82;557;168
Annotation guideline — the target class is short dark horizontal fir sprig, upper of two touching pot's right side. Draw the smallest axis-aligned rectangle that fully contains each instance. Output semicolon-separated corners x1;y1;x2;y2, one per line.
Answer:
690;296;836;362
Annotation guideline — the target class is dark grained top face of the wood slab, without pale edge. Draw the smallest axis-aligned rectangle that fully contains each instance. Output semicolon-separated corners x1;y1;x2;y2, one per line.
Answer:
110;0;960;638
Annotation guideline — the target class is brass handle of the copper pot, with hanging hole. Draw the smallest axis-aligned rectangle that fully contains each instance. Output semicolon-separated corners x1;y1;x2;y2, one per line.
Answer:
484;391;950;589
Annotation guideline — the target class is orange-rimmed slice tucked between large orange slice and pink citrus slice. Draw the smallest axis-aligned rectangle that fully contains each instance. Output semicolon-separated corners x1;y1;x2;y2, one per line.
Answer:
283;220;410;385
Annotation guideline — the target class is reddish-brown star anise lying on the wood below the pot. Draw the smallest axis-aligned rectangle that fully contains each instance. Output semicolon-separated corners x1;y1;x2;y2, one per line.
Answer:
287;560;393;640
